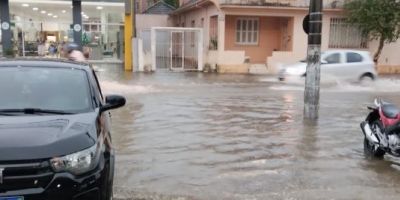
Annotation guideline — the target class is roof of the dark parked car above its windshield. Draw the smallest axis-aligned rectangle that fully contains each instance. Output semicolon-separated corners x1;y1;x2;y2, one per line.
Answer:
0;58;90;70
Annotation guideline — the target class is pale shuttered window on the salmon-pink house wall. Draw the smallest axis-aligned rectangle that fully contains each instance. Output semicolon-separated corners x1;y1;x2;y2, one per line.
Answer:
236;18;259;45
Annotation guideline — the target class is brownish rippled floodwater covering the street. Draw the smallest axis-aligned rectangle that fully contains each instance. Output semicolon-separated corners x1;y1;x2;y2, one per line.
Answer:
94;66;400;200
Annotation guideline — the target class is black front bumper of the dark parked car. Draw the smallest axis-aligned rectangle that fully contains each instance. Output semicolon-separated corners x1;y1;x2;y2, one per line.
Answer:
0;169;108;200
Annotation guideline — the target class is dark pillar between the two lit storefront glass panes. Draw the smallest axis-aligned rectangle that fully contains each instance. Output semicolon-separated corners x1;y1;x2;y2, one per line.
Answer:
72;0;82;49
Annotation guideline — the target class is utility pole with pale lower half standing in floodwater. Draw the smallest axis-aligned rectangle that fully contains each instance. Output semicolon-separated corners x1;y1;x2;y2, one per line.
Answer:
304;0;322;120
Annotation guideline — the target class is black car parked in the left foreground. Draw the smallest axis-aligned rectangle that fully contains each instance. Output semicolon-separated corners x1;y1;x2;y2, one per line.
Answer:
0;59;125;200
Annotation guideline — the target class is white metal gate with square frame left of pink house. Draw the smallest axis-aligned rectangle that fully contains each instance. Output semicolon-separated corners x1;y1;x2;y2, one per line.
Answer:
151;27;203;71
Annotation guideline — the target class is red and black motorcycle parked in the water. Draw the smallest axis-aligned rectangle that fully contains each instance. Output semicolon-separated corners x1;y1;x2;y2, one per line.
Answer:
361;99;400;158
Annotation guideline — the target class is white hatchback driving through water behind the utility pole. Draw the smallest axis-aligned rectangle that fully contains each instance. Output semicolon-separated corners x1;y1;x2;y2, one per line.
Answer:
278;50;378;82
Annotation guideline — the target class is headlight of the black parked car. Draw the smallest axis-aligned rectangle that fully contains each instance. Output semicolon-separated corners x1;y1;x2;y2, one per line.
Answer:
50;144;98;175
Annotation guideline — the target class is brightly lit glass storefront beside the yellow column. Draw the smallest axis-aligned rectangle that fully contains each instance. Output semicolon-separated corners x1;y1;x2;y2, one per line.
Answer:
0;0;124;61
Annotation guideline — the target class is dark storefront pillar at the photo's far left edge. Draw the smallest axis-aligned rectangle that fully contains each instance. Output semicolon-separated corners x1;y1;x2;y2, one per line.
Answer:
0;0;13;54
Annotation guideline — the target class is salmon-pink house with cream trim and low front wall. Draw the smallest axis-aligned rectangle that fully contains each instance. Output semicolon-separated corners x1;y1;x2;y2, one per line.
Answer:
172;0;400;73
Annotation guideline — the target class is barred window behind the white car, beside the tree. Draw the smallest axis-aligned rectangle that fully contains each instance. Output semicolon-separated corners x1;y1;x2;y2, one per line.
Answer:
329;18;368;49
